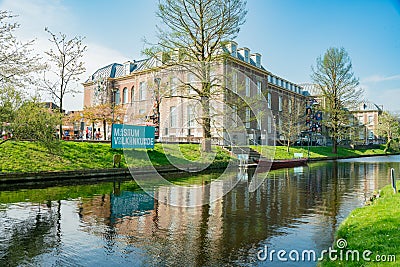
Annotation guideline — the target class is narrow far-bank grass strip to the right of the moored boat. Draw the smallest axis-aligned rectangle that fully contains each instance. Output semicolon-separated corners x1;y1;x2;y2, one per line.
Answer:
251;146;385;159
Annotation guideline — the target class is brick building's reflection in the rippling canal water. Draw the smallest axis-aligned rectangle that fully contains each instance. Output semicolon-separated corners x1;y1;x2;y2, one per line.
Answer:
78;162;396;266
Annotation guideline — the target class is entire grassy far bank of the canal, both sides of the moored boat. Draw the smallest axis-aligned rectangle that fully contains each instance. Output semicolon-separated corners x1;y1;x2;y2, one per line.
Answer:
0;141;396;178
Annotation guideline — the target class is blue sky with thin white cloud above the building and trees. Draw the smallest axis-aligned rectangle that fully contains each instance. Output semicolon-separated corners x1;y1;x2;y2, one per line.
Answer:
0;0;400;112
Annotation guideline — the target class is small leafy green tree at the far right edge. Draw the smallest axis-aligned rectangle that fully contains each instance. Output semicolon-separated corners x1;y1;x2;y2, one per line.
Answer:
377;112;400;153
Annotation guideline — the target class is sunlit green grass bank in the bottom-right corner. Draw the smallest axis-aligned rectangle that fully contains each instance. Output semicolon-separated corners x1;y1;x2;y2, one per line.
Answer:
321;182;400;266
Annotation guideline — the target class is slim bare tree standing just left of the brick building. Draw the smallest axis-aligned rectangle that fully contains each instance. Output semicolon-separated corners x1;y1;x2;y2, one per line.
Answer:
44;28;87;138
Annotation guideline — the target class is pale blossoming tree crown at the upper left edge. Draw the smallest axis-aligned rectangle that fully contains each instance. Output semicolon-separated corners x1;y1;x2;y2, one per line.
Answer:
0;10;45;87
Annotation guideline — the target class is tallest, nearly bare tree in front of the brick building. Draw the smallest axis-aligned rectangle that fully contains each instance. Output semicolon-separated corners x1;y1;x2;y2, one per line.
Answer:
145;0;247;152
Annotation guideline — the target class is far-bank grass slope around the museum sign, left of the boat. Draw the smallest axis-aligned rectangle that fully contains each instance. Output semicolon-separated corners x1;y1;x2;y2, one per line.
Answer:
0;141;230;172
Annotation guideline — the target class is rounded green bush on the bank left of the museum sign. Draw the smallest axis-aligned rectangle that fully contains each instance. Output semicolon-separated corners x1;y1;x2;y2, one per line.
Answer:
12;100;61;154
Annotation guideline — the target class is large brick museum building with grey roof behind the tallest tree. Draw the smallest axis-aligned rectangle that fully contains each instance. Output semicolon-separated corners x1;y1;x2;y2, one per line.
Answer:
83;42;306;144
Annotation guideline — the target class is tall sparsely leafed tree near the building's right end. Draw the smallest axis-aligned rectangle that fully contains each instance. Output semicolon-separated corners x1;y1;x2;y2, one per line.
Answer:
311;48;362;153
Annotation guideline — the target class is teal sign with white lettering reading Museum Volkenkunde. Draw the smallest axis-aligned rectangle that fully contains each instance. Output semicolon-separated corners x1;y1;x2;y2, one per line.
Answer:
111;124;154;148
